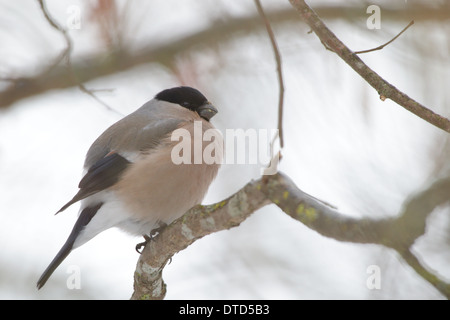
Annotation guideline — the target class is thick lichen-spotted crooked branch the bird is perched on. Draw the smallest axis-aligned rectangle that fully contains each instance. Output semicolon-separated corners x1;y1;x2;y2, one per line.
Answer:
132;173;450;299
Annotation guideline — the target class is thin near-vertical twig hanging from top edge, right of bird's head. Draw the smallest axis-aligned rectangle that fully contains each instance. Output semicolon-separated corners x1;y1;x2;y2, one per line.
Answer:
255;0;284;148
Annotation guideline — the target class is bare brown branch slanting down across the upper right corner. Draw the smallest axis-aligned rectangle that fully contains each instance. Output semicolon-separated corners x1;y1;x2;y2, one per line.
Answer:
289;0;450;133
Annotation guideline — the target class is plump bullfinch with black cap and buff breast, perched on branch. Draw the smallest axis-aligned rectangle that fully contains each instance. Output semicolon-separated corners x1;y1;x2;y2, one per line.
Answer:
37;86;221;289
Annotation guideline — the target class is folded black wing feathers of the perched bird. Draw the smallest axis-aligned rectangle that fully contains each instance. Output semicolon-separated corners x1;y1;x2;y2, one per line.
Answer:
57;152;131;213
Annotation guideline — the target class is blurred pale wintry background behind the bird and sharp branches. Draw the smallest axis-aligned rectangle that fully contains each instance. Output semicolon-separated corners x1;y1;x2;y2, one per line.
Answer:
0;0;450;299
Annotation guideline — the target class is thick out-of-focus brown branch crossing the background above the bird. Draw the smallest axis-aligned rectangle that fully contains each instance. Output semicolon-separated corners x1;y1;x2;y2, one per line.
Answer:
0;5;448;109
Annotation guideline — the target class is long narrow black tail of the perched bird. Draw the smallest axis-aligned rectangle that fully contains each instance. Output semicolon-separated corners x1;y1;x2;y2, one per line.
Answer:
36;203;103;289
